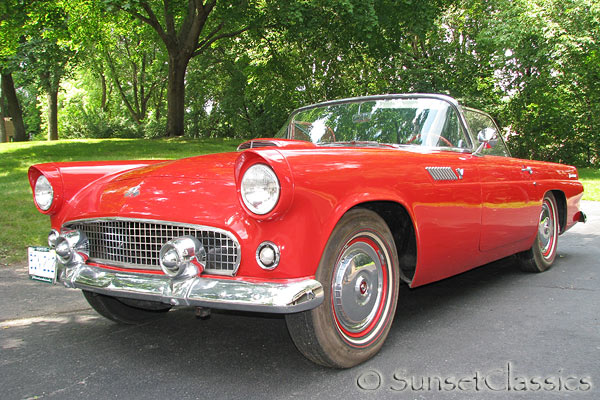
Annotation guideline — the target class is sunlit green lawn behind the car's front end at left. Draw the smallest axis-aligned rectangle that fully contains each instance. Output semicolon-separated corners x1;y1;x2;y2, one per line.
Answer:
0;139;240;266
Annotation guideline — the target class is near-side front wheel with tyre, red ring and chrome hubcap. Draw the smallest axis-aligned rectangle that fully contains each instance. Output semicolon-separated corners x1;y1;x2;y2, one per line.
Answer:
286;209;400;368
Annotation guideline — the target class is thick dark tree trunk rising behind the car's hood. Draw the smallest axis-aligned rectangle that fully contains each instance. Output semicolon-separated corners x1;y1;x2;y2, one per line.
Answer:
167;56;190;137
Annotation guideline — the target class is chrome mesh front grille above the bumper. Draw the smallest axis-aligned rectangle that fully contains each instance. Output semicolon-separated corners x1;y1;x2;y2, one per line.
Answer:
64;218;240;275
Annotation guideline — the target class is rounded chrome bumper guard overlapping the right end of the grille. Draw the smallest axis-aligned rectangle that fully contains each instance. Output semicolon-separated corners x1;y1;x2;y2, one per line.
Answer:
159;236;206;278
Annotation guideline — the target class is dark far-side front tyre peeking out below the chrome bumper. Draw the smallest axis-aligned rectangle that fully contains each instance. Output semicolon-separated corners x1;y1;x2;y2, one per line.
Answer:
83;290;171;325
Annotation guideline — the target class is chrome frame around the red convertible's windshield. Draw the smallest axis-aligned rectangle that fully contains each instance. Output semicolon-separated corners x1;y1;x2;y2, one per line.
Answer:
286;93;475;153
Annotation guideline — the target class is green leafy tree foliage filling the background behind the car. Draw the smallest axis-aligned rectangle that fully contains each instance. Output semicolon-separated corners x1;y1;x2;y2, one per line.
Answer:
0;0;600;166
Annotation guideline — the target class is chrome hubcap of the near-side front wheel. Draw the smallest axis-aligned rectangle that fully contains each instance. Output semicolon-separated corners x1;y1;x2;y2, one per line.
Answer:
332;241;383;333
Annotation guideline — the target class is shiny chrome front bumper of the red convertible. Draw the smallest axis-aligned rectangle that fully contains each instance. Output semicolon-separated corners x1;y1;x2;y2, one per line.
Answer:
58;263;323;314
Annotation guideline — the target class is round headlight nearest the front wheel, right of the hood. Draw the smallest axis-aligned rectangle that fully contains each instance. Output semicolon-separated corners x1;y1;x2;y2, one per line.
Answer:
240;164;281;215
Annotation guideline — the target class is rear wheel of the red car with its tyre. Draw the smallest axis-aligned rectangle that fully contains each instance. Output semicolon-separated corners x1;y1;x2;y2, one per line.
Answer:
517;192;559;272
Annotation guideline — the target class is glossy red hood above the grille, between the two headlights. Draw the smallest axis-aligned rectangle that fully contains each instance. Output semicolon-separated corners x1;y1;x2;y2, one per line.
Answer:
57;153;239;227
